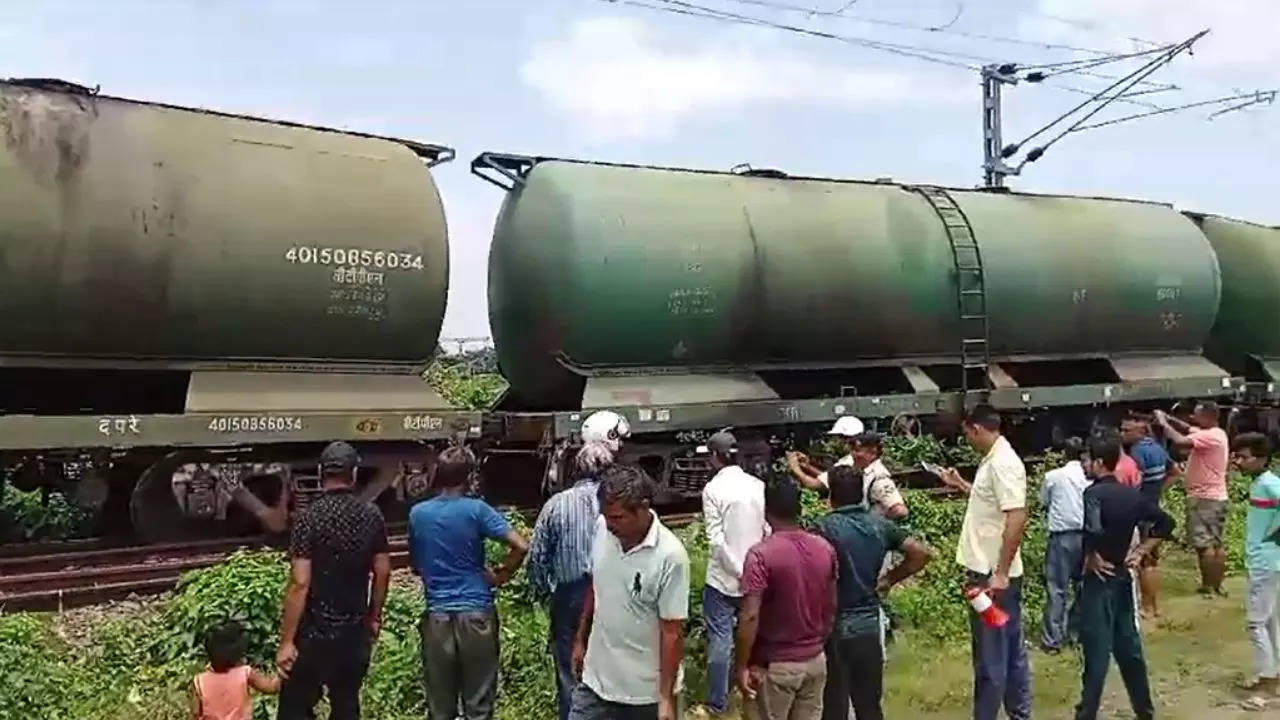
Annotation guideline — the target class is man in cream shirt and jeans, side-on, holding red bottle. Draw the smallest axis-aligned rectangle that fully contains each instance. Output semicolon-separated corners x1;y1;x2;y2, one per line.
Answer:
942;405;1032;720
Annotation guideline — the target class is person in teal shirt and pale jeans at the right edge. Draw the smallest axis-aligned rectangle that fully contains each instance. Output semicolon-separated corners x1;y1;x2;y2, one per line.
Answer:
1231;433;1280;696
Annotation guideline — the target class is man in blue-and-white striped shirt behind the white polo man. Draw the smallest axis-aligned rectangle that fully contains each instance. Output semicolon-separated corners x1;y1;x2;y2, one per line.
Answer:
529;411;627;720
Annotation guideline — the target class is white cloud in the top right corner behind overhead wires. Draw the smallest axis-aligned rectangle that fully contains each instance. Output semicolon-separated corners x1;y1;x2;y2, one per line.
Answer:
1020;0;1280;69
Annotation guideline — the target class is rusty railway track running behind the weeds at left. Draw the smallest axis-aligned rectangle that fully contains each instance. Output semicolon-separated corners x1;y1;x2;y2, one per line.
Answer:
0;512;698;612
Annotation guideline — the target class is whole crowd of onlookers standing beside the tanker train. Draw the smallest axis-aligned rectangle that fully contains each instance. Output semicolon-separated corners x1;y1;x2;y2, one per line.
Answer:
185;402;1280;720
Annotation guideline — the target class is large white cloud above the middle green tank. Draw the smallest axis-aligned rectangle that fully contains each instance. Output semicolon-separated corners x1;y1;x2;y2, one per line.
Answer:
520;18;973;141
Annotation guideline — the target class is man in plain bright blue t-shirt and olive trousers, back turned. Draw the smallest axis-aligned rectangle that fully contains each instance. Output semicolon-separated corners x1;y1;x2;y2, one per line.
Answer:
408;447;529;720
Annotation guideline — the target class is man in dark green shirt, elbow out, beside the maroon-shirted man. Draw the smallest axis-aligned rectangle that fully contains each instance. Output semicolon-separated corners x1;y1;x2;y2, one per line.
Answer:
818;465;932;720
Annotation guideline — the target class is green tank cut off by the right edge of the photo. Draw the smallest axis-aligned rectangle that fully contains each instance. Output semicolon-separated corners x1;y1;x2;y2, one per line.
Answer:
1199;215;1280;372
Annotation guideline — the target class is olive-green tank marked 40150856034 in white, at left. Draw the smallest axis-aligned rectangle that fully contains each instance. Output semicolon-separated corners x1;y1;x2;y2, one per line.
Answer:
0;83;448;372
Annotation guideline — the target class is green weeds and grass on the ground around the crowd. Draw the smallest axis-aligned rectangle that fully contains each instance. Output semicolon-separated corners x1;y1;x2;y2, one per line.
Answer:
0;456;1247;720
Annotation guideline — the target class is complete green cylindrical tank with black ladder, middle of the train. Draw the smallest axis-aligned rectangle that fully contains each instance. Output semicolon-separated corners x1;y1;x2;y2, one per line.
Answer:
489;160;1219;404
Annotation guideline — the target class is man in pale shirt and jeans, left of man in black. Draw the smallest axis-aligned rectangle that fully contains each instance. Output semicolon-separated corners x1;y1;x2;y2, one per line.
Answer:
1039;437;1089;655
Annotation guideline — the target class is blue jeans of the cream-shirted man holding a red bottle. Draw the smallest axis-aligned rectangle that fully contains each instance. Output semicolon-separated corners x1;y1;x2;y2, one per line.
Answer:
969;573;1032;720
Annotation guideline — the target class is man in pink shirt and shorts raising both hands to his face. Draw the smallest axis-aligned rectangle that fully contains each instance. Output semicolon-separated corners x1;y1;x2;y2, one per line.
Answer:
1156;401;1230;596
